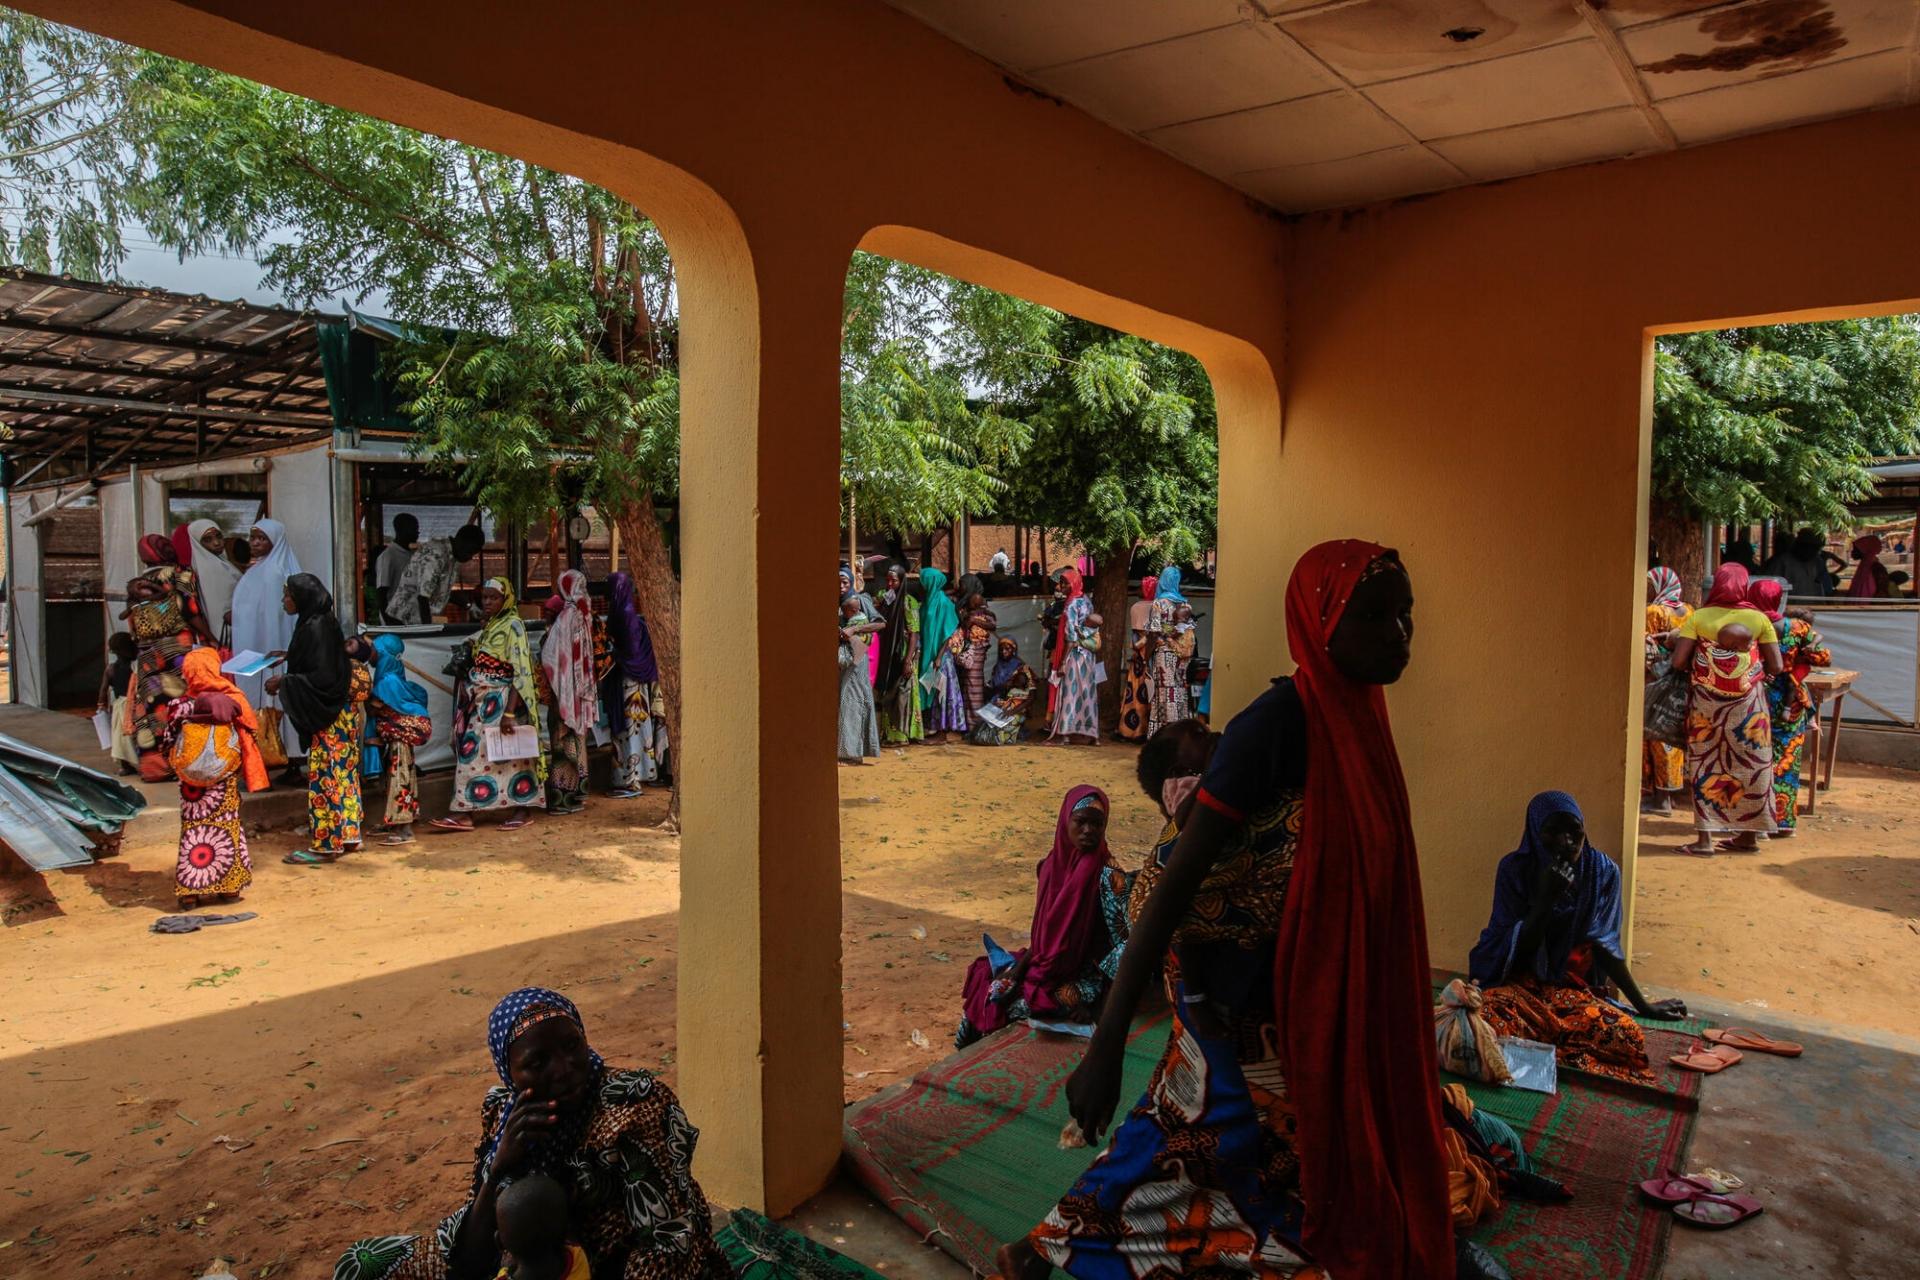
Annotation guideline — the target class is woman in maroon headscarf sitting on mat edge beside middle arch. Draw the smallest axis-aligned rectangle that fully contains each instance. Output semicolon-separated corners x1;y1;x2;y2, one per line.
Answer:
954;785;1133;1050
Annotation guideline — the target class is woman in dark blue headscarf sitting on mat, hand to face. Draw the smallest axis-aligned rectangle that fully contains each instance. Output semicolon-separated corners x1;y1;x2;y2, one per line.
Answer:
1469;791;1686;1084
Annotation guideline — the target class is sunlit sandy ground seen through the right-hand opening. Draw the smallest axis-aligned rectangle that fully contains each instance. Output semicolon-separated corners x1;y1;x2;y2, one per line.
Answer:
1632;764;1920;1036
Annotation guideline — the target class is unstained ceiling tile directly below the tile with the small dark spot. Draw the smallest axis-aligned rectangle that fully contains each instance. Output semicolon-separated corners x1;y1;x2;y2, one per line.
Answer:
1365;40;1634;138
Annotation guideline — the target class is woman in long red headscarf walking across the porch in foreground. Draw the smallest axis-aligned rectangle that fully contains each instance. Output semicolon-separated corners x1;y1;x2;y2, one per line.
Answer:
1000;541;1471;1280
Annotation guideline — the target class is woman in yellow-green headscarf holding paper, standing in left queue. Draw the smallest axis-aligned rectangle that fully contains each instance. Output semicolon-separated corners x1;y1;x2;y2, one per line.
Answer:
432;578;547;831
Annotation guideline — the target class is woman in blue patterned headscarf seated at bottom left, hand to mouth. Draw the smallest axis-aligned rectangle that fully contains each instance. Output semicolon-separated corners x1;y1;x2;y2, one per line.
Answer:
334;986;732;1280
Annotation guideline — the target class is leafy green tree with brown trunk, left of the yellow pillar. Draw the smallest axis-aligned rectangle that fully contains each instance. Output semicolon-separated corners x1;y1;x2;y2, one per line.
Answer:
127;56;680;782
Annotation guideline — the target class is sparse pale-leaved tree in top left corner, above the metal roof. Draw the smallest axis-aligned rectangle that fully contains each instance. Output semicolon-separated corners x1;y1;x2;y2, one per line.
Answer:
0;10;146;280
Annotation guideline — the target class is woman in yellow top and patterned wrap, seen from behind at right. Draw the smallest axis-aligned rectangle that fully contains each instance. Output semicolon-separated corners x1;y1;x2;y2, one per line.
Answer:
1672;564;1782;858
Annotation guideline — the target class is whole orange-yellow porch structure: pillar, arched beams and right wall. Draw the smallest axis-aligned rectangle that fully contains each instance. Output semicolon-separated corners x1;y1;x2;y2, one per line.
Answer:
23;0;1920;1213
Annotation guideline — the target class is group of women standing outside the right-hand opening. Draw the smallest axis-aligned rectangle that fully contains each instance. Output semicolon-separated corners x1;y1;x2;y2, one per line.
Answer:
1642;562;1832;858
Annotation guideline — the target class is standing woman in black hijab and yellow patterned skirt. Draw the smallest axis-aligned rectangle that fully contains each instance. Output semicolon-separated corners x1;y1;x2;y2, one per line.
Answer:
267;574;371;865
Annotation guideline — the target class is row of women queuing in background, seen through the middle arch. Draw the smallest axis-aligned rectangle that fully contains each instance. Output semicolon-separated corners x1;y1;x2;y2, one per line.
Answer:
837;564;1194;764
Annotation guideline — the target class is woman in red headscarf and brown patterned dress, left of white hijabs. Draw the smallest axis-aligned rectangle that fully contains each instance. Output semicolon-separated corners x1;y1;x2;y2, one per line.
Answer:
121;533;215;783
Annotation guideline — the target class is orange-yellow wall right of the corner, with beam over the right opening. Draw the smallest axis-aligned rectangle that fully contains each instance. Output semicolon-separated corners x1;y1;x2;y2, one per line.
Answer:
1282;111;1920;965
